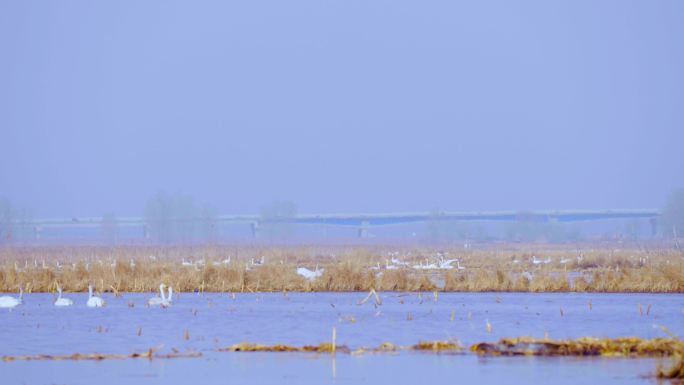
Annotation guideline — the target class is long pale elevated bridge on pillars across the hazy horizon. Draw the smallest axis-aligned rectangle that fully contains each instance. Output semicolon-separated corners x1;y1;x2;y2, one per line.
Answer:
22;209;660;237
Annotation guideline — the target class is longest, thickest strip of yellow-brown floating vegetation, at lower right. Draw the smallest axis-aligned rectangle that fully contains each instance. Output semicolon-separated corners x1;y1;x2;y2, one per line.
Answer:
470;337;684;357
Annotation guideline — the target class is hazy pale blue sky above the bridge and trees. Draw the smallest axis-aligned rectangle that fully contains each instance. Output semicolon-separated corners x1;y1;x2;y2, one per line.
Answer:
0;0;684;216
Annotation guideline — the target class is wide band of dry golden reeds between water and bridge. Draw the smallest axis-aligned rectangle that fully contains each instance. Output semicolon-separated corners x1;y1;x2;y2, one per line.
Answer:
0;245;684;294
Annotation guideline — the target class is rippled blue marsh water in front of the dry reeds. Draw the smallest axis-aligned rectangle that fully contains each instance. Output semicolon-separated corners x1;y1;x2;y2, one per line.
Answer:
0;293;684;384
